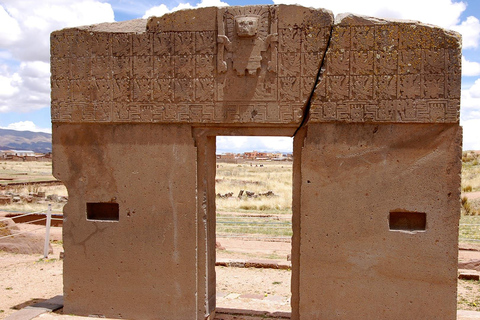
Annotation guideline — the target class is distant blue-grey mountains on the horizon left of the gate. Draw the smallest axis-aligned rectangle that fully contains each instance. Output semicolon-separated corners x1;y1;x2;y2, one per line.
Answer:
0;129;52;153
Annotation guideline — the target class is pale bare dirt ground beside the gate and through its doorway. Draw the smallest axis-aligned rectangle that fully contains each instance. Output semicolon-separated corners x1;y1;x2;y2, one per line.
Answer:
0;228;480;319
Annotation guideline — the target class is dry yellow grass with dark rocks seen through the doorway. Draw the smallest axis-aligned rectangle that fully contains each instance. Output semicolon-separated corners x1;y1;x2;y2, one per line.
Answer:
215;161;292;214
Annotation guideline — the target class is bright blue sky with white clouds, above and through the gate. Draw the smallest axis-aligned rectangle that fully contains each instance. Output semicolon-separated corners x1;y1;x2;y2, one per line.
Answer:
0;0;480;152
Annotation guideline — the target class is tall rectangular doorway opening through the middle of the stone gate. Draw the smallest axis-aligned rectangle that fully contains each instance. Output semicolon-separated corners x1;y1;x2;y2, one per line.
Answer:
215;136;293;312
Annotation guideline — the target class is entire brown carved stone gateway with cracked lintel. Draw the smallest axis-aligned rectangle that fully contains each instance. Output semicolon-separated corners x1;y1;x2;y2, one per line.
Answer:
51;5;461;320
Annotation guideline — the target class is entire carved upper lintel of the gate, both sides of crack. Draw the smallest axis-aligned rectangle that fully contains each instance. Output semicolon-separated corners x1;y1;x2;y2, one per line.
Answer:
51;6;461;125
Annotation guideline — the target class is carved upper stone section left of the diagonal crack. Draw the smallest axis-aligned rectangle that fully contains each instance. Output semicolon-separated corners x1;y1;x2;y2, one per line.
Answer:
51;5;333;125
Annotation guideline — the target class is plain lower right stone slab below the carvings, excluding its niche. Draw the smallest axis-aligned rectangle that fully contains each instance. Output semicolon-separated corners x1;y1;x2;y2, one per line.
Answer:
292;123;461;319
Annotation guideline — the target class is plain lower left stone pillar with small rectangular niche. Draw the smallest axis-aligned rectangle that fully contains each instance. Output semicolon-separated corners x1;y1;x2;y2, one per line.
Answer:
53;124;199;319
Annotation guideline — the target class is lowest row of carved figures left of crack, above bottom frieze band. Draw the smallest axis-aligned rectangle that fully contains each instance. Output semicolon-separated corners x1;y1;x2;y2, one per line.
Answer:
51;77;315;103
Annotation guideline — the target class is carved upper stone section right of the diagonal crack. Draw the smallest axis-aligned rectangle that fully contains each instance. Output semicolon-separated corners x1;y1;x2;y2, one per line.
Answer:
310;14;461;123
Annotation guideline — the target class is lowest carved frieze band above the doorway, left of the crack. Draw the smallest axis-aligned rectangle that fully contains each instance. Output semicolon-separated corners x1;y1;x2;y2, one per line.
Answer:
52;102;303;124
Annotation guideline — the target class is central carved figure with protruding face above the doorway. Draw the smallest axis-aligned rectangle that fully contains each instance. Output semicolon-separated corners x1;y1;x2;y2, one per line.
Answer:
216;6;278;101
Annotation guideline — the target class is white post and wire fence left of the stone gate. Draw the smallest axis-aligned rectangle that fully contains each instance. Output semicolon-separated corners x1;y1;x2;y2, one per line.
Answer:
0;204;62;259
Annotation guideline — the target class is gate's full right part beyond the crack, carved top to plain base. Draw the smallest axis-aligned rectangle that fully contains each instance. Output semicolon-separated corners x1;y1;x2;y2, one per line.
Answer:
294;15;461;319
